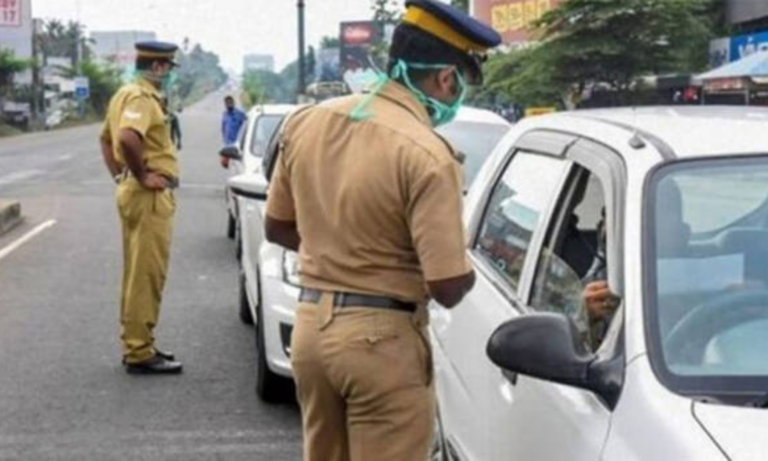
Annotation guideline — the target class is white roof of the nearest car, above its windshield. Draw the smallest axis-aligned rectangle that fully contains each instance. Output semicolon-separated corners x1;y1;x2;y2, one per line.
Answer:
542;106;768;158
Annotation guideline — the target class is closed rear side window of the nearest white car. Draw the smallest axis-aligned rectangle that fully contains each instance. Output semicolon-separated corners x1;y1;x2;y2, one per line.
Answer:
475;152;568;291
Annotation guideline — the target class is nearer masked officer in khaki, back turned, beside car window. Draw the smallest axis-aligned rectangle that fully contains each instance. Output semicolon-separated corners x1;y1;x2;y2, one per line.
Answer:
266;0;500;461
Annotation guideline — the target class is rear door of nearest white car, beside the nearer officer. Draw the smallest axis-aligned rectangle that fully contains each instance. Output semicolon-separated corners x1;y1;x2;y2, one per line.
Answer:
431;142;570;461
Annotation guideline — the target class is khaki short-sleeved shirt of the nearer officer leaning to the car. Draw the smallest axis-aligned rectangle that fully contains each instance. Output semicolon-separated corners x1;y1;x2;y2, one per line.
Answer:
267;82;471;303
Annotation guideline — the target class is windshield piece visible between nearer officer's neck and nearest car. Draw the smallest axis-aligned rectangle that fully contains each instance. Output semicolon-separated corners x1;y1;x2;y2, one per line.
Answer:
437;121;509;188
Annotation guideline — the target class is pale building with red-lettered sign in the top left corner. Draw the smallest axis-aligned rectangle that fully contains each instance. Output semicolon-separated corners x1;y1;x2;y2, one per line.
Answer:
0;0;34;84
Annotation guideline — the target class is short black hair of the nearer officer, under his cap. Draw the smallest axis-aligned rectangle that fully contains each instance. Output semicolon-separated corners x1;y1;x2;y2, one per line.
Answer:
387;23;472;82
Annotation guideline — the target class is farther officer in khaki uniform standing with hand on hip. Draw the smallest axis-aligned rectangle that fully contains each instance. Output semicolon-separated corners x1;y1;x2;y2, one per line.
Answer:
101;42;182;374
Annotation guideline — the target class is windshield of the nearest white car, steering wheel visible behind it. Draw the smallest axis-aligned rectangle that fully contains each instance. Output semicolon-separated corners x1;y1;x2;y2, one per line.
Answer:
646;157;768;393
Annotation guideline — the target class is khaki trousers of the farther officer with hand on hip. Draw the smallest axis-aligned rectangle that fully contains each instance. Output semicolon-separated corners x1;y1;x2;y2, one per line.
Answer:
117;177;176;363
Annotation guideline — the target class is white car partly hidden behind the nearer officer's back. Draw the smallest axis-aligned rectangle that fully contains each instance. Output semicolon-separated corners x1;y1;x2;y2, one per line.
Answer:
229;108;510;401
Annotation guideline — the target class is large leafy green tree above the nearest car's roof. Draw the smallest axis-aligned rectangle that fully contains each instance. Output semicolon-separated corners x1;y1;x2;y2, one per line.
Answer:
528;0;713;107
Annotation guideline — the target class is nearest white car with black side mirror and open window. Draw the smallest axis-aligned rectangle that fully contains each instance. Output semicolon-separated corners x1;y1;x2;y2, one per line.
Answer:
430;107;768;461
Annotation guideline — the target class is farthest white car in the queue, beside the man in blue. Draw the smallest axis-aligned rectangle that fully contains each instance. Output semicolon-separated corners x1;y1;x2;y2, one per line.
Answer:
220;104;296;258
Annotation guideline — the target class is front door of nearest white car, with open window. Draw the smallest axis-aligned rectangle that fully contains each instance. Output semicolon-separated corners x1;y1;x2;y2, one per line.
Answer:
487;139;621;461
